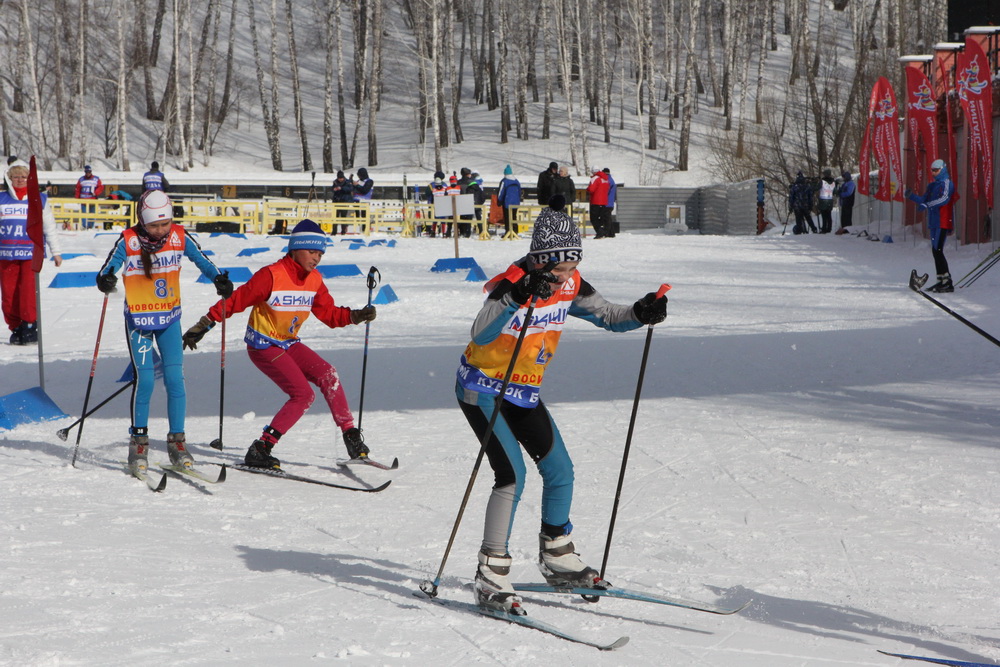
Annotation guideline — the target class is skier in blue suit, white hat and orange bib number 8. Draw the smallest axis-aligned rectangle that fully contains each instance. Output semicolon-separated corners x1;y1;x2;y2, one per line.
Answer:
97;190;233;477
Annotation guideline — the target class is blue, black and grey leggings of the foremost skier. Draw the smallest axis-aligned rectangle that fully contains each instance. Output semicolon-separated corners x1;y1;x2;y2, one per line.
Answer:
457;387;573;553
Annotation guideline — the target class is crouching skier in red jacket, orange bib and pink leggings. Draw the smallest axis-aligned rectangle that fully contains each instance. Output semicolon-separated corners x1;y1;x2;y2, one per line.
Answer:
184;219;376;470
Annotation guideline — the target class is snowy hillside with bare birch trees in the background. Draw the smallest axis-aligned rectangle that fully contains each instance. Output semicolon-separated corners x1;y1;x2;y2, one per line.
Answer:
0;0;947;190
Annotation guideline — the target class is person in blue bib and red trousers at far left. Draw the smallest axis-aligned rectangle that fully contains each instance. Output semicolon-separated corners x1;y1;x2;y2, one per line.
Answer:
0;158;62;345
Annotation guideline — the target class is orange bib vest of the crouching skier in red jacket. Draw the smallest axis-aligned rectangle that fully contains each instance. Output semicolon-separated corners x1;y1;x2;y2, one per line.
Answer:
243;263;323;350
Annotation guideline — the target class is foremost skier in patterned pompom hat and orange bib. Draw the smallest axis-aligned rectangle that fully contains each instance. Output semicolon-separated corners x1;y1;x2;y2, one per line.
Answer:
455;200;667;614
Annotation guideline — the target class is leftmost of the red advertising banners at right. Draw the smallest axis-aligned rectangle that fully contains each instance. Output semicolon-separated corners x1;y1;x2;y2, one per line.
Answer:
858;76;903;201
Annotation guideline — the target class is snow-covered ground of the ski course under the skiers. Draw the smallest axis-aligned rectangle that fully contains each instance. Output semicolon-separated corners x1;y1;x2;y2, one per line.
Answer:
0;230;1000;667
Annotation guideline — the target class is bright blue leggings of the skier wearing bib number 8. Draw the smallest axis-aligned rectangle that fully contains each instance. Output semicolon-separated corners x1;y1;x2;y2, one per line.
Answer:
125;319;187;433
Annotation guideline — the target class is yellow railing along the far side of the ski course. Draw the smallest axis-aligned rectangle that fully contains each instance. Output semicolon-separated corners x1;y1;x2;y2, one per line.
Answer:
48;197;590;240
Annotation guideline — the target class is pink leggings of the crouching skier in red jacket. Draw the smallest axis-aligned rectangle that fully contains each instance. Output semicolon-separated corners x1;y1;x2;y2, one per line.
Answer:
247;343;354;434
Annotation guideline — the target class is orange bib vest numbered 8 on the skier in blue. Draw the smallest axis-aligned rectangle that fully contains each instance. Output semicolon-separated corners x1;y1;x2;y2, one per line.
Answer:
122;225;187;331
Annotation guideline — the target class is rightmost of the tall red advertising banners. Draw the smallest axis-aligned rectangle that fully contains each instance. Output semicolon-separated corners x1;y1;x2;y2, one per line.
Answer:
955;37;993;208
